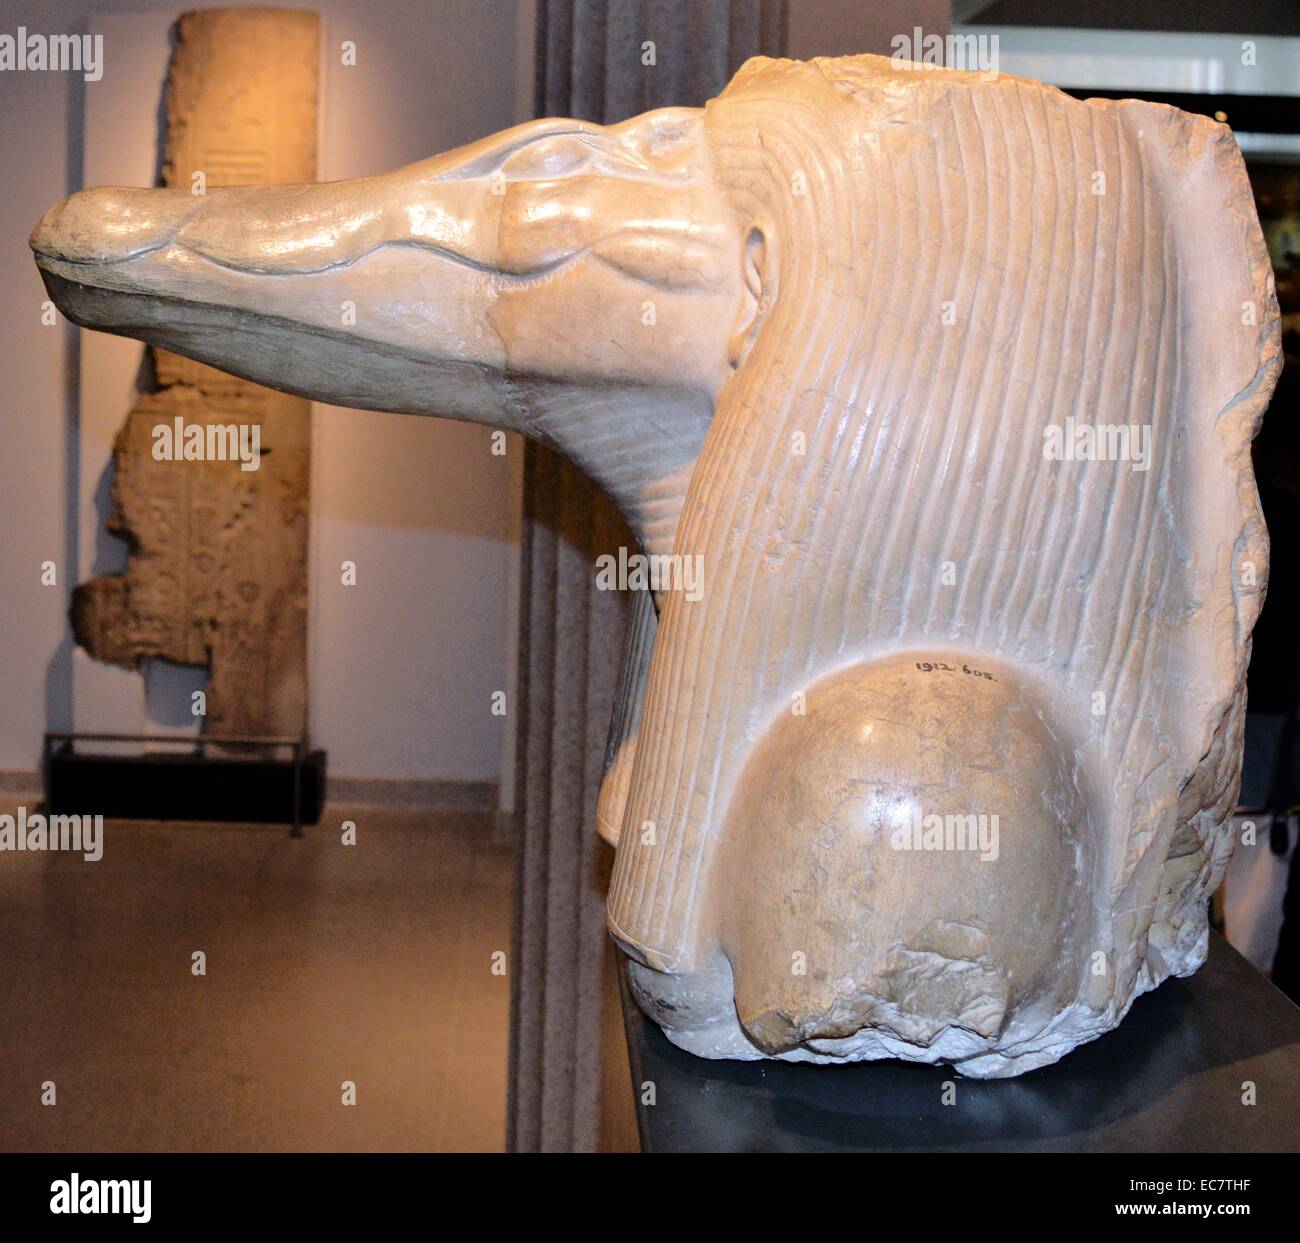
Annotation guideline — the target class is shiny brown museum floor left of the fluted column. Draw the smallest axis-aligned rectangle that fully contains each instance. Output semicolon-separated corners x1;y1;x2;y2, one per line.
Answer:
0;802;514;1152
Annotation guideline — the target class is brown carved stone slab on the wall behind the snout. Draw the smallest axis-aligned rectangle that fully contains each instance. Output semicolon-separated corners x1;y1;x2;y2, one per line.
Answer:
73;9;319;737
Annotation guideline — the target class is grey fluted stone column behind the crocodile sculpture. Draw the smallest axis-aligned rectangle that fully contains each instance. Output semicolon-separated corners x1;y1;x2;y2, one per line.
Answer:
507;0;785;1152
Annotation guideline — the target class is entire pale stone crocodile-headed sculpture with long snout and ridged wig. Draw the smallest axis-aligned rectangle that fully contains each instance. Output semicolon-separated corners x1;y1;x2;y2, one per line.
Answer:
31;56;1279;1077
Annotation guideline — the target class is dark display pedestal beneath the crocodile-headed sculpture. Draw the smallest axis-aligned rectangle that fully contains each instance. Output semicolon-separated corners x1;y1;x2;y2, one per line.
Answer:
620;935;1300;1152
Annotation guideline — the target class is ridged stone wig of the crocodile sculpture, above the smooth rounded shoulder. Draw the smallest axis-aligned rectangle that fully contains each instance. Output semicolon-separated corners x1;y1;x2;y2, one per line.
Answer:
610;57;1277;1008
